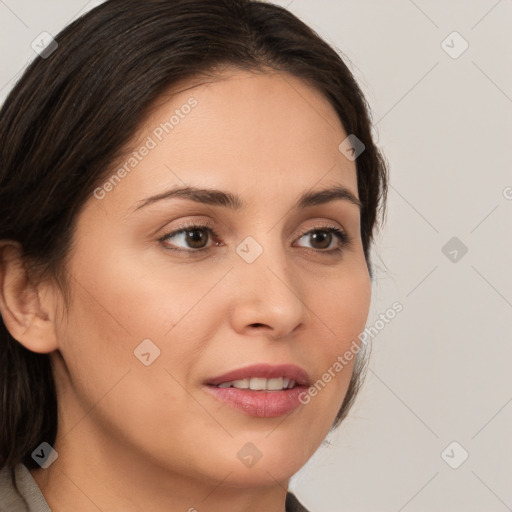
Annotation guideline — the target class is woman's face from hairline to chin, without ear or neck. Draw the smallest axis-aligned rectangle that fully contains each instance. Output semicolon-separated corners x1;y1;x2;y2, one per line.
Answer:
46;71;370;487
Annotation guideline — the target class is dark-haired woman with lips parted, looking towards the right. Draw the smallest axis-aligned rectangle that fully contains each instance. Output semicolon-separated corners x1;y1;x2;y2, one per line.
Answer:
0;0;387;512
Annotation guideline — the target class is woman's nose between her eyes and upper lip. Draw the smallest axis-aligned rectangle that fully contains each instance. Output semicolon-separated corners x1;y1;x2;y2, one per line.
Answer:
230;240;309;339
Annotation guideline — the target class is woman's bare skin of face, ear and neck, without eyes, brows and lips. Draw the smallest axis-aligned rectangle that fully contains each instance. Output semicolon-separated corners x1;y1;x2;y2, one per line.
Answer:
0;69;371;512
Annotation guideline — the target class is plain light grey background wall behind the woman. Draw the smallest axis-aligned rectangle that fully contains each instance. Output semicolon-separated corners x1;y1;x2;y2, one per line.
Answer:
0;0;512;512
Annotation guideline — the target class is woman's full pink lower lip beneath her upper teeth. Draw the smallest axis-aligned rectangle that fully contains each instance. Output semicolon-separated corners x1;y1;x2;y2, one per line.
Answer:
206;386;307;418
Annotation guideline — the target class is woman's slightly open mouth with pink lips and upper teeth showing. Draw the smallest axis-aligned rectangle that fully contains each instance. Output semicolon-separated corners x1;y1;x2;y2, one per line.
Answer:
204;364;310;418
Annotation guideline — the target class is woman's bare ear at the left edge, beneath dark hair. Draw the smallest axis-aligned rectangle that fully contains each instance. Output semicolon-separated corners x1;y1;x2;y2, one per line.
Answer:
0;240;59;353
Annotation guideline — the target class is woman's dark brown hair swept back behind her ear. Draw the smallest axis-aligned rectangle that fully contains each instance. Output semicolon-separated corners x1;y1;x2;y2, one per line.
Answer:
0;0;387;478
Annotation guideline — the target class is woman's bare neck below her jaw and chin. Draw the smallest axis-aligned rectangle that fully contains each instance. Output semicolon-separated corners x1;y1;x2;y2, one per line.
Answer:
30;424;288;512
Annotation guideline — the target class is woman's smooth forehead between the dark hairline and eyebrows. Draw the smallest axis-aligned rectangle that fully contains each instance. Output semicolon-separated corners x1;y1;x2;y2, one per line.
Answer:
94;70;357;214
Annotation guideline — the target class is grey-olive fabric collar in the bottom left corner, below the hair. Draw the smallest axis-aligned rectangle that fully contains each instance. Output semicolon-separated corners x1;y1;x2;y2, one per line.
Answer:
0;464;51;512
